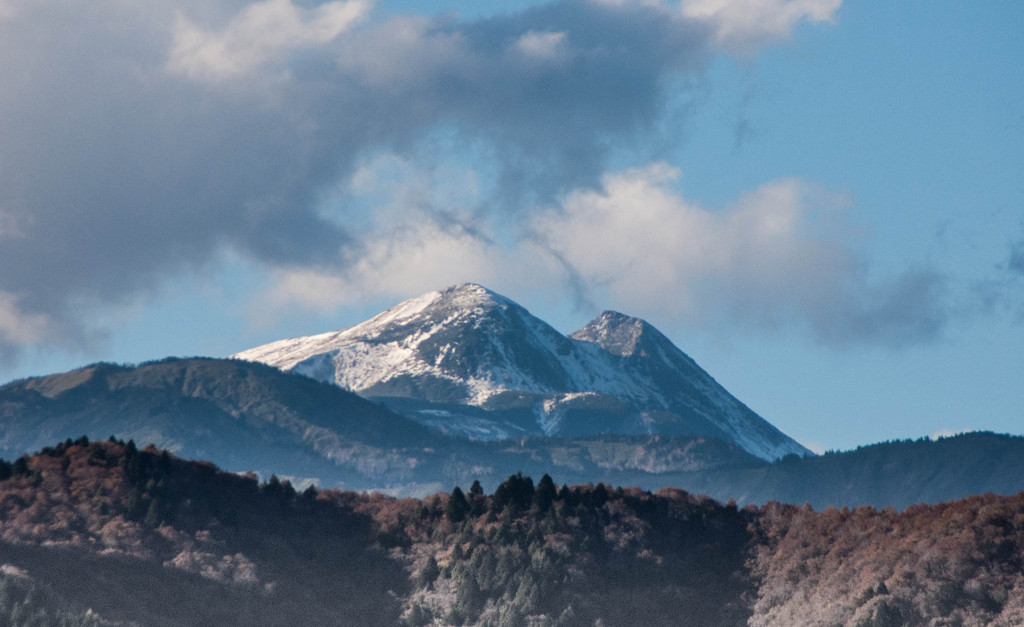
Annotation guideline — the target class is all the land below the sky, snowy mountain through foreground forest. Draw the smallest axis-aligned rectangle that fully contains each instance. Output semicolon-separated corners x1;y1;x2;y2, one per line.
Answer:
0;285;1024;627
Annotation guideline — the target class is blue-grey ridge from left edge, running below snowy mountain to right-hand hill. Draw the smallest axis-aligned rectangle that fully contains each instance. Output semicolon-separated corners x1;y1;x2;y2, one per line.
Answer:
0;359;762;495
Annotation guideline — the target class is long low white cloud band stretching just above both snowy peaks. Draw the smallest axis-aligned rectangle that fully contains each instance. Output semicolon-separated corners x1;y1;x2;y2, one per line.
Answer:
272;162;949;346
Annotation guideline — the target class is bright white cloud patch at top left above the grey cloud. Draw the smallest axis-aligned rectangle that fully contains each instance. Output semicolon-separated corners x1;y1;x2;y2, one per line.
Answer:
168;0;372;80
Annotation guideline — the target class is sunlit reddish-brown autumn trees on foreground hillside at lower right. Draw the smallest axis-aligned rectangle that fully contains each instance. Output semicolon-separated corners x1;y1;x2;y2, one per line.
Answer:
752;494;1024;625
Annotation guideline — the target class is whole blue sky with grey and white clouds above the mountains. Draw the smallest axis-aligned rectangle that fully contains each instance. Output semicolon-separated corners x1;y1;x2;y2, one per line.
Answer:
0;0;1024;450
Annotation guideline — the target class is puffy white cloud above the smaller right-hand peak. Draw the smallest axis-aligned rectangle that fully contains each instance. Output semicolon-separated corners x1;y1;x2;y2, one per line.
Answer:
534;163;854;322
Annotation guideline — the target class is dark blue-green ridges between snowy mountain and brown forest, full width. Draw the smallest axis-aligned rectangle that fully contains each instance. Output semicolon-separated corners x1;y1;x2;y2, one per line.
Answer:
0;352;1024;507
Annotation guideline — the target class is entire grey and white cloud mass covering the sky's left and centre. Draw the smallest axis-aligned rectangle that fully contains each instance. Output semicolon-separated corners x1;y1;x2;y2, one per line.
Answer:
8;0;962;359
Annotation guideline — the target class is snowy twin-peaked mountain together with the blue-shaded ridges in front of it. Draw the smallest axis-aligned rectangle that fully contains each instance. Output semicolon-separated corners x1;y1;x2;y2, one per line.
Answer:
0;285;1024;507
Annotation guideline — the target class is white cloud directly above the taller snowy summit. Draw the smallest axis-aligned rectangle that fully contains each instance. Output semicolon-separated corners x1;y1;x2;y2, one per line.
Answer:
256;154;561;317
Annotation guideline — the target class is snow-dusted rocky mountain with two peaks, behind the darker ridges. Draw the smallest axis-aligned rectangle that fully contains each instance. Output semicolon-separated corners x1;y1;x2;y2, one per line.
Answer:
232;284;809;459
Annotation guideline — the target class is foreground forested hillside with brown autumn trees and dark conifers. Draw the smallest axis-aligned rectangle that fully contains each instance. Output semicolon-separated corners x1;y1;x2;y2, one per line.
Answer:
0;438;1024;626
